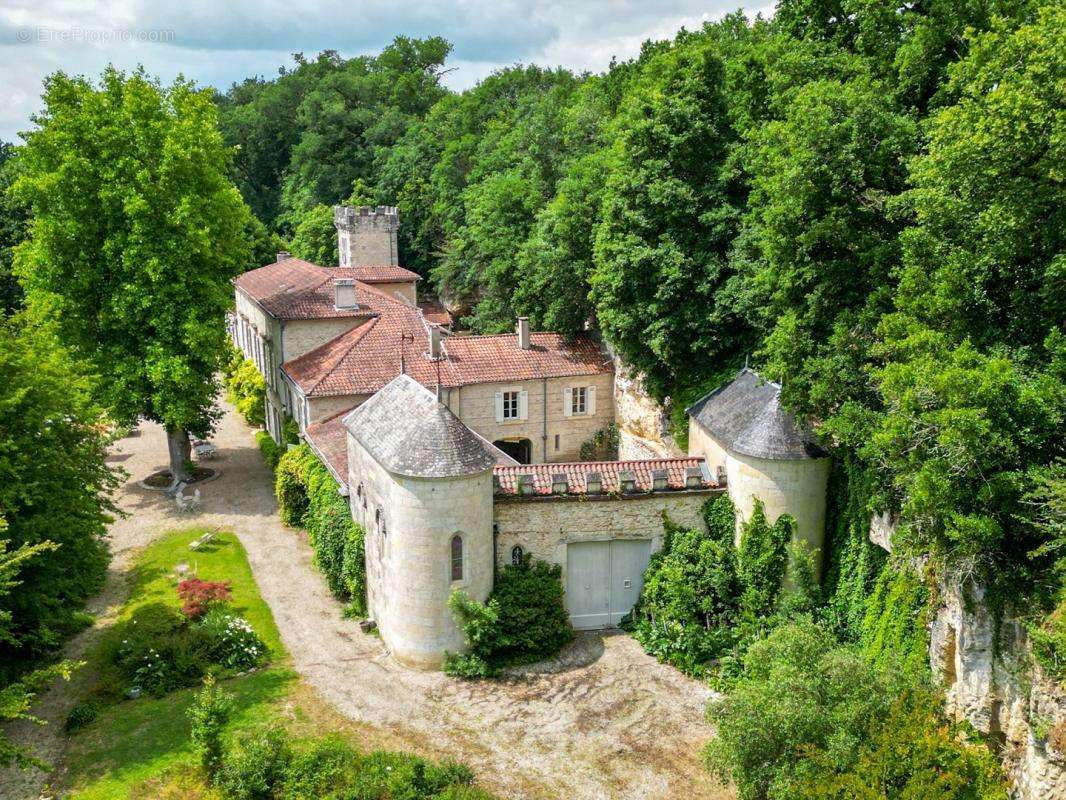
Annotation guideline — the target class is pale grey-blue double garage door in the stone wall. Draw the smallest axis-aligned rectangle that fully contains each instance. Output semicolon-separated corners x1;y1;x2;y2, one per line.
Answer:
566;539;651;630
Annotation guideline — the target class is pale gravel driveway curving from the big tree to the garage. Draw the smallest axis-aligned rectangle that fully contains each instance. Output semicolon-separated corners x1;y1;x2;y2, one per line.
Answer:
0;412;731;800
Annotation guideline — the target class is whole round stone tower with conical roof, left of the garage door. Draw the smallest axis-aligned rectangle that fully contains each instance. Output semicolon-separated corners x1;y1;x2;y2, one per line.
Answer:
344;374;497;669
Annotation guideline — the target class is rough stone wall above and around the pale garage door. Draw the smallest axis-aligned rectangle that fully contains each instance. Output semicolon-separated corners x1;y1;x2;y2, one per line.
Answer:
494;489;724;586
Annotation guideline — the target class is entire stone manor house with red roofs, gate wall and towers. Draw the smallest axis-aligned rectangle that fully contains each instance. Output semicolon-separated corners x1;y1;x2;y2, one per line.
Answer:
230;206;828;668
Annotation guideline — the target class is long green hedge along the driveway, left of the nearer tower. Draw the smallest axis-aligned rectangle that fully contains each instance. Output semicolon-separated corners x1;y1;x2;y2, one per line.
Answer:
274;445;367;615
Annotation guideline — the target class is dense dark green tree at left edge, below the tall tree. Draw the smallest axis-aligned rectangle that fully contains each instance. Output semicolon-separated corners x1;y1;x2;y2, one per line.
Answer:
0;317;117;683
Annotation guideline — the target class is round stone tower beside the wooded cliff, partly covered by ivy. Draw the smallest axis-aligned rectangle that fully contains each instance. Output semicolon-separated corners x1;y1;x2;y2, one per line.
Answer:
688;369;829;566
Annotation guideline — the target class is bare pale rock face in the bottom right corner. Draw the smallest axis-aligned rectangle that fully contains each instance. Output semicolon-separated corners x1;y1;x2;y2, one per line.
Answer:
930;581;1066;800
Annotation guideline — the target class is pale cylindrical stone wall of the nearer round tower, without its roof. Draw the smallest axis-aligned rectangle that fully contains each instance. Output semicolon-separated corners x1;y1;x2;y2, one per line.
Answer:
348;426;492;669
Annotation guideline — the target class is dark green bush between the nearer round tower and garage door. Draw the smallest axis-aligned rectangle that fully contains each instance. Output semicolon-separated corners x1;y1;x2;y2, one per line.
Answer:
443;555;574;677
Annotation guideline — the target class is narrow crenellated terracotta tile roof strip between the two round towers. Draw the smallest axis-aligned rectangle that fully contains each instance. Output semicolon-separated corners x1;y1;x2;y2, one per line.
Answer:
492;457;720;496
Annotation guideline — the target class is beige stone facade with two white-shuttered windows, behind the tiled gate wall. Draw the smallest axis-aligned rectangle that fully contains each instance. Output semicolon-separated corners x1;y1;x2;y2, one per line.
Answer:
443;373;614;464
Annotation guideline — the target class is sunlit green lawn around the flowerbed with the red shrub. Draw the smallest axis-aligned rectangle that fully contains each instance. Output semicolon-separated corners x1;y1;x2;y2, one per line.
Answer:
60;529;296;800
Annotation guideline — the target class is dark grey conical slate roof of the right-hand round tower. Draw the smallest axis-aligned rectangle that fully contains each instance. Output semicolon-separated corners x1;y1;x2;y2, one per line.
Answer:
687;369;826;461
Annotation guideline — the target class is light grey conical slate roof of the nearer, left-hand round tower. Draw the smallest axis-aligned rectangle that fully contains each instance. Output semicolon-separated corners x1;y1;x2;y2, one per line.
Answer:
344;374;501;478
